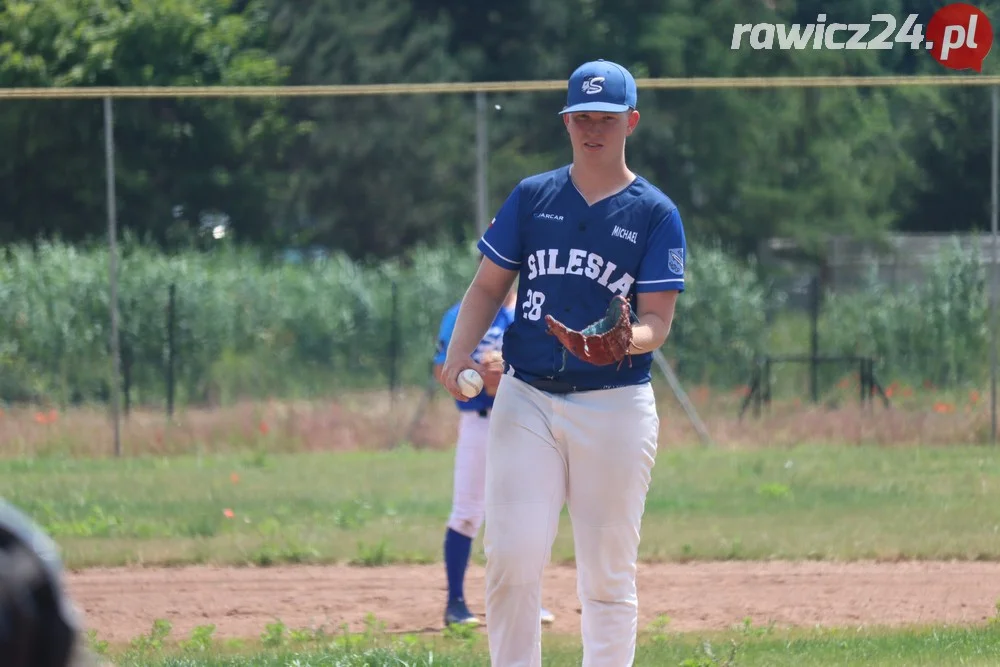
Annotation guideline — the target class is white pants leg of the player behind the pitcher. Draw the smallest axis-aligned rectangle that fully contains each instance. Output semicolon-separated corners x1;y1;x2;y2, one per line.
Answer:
447;410;490;540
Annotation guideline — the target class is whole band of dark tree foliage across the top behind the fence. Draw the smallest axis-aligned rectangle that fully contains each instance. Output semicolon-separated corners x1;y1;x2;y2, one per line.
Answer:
0;0;988;258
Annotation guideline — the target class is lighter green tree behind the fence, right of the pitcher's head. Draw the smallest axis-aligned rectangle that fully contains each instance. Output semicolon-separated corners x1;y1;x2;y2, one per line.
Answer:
612;0;924;253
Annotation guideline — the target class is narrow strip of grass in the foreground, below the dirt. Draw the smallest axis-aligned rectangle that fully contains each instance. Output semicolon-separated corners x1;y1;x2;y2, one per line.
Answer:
88;626;1000;667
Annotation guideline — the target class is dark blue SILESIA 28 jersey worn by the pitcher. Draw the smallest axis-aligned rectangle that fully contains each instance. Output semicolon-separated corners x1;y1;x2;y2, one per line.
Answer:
478;165;687;389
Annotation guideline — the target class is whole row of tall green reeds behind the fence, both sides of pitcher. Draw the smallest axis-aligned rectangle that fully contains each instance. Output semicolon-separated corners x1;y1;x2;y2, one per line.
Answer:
0;239;987;405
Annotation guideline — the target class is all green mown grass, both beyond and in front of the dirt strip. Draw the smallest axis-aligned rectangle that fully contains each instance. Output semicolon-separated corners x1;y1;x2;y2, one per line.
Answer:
0;434;1000;667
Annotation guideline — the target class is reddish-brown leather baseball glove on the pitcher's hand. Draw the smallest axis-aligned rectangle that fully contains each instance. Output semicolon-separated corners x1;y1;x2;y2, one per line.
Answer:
545;295;638;367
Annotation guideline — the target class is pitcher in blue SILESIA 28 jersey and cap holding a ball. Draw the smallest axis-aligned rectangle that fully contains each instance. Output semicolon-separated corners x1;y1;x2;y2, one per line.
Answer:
441;60;686;667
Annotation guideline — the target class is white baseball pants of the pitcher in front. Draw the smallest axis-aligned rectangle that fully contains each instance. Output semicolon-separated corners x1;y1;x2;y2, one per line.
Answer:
484;375;659;667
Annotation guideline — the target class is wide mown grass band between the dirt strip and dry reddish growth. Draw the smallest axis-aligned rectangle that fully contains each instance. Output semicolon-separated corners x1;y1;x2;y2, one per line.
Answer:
0;446;1000;567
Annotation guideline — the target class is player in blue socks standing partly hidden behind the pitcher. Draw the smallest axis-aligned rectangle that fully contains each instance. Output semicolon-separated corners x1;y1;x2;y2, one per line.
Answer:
434;255;555;625
